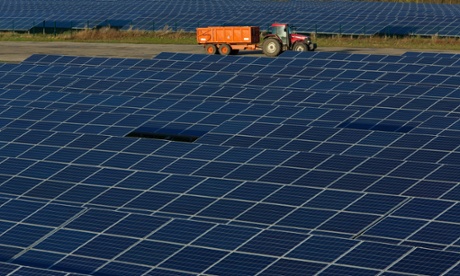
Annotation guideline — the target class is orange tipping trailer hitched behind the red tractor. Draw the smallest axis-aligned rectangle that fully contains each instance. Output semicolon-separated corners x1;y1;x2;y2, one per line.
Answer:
196;26;260;55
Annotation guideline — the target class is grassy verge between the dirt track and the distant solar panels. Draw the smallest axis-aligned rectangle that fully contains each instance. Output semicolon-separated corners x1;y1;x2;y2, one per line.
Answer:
0;28;460;51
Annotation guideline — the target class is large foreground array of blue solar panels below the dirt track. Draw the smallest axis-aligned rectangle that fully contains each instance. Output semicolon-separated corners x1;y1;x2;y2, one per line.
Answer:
0;48;460;275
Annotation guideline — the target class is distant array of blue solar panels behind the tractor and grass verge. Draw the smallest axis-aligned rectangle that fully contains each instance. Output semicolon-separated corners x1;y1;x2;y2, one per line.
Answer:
0;0;460;37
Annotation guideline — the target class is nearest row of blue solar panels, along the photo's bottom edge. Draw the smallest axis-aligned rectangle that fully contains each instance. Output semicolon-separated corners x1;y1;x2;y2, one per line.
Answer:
0;197;458;275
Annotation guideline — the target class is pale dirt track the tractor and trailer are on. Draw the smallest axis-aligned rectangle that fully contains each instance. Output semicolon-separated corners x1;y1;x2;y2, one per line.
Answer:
0;42;434;63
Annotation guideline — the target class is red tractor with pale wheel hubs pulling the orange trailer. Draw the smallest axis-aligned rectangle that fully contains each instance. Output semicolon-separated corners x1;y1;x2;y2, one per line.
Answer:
262;23;317;57
